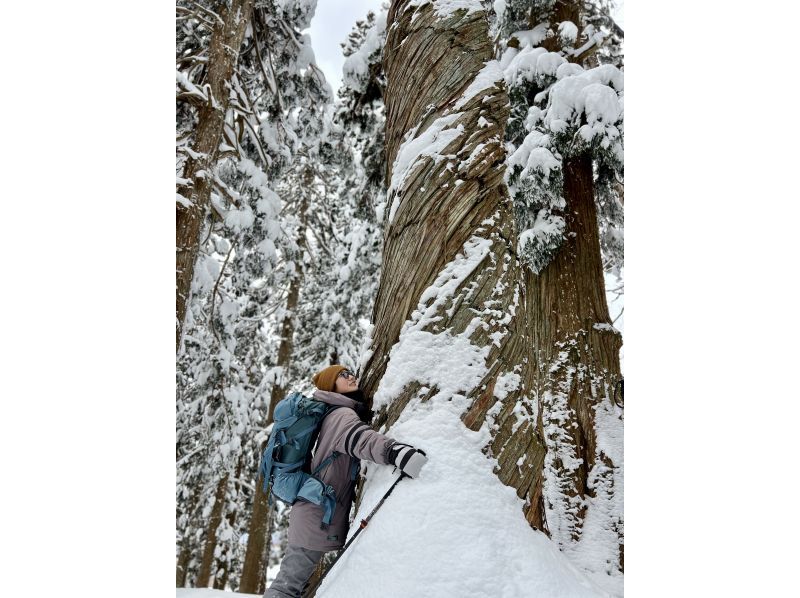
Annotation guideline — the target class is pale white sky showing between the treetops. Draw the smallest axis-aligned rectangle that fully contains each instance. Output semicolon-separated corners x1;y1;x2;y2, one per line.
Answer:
307;0;625;94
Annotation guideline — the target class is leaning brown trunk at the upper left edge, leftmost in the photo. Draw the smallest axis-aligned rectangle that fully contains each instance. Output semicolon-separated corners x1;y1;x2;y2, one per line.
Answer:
175;0;253;351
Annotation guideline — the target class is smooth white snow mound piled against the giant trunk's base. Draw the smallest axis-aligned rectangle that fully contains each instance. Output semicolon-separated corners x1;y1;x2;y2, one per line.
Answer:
318;395;607;598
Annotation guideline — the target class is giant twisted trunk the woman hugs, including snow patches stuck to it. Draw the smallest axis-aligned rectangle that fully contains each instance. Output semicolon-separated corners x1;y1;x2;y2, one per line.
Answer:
361;1;544;527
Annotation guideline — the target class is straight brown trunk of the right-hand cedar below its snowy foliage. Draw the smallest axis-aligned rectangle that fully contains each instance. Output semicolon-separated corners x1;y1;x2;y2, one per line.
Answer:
526;154;623;570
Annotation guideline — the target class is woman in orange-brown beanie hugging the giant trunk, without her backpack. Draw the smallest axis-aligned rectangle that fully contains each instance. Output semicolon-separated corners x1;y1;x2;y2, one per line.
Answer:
264;365;428;598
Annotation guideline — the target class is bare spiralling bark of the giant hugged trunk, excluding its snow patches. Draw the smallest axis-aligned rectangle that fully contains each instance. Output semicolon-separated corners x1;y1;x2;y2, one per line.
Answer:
361;1;544;527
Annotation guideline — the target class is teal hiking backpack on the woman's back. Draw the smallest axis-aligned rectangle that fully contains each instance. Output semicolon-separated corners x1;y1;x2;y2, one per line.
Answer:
259;392;350;529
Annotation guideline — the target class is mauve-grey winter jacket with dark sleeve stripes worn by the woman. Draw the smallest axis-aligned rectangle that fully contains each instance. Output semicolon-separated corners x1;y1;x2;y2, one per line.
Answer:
289;390;395;551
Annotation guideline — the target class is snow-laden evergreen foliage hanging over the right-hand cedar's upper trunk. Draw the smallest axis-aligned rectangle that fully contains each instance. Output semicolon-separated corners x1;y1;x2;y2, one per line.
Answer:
493;0;624;275
